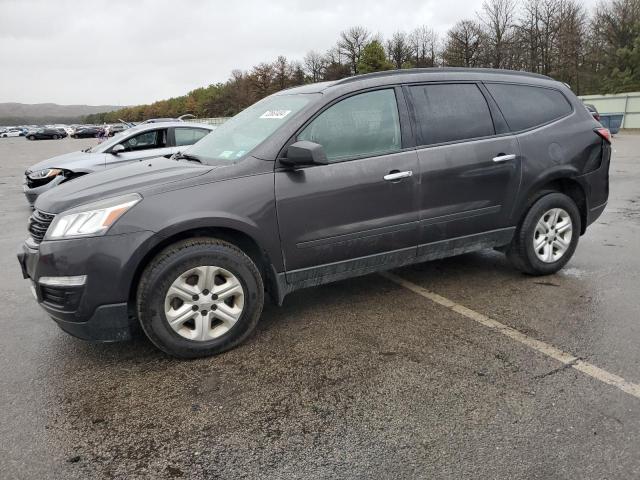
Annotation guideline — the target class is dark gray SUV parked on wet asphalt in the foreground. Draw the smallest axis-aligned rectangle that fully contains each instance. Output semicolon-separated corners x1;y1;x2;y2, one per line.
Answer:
18;69;611;357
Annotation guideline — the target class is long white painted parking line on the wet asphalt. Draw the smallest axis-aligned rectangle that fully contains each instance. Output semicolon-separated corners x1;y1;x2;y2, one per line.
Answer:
381;272;640;398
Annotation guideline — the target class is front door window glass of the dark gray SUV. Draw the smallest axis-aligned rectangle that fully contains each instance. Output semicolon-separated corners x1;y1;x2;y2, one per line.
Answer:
298;89;402;161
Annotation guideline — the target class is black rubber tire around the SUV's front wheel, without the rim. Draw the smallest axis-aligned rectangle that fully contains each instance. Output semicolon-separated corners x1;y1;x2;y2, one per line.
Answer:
136;238;264;358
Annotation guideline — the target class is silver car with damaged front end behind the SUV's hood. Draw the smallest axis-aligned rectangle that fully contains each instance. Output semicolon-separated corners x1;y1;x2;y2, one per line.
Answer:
24;121;215;205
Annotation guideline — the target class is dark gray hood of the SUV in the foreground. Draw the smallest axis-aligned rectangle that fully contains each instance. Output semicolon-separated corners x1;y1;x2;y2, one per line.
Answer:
35;157;213;213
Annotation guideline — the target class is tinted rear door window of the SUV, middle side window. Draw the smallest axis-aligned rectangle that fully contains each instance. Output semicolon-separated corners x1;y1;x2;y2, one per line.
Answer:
408;83;495;145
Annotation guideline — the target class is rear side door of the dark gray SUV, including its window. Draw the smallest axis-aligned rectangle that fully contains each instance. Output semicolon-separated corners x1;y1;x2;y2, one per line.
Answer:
405;82;521;251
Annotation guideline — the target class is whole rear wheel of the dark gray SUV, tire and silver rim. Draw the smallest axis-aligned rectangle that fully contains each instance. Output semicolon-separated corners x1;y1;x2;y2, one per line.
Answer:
507;192;581;275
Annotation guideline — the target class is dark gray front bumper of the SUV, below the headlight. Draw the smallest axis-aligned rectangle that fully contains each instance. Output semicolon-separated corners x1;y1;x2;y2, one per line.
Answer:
18;232;153;342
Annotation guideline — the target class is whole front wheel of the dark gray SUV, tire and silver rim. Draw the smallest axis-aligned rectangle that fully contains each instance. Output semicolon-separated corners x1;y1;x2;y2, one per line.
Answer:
137;238;264;358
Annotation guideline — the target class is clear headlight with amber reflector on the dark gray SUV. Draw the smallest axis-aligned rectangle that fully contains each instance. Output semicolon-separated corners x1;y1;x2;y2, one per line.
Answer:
47;193;142;240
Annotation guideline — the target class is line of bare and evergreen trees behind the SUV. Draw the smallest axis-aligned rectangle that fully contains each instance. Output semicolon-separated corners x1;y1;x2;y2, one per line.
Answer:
86;0;640;122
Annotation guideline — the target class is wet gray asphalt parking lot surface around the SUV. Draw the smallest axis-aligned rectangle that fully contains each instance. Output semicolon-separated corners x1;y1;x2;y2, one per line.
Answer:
0;134;640;479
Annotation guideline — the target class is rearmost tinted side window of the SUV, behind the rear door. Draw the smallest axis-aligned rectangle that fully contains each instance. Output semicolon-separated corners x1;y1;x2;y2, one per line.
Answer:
486;83;571;131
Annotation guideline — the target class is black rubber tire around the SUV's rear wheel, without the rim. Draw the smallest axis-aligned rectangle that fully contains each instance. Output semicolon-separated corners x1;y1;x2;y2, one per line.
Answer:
506;192;581;275
